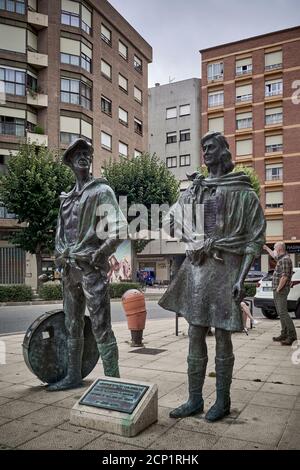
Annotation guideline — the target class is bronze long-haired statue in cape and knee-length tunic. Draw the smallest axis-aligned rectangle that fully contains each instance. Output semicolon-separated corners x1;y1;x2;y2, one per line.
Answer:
159;132;265;421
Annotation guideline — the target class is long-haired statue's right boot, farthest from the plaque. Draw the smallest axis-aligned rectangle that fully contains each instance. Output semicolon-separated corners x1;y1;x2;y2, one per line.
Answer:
205;355;234;421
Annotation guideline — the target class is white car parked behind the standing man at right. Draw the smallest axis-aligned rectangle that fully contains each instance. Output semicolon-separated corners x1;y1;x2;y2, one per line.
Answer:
254;268;300;319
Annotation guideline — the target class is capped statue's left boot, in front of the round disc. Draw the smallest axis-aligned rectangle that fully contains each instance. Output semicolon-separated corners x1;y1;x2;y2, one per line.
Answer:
47;338;84;392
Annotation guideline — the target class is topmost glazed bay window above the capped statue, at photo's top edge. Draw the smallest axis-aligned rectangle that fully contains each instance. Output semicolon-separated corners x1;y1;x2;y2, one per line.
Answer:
61;0;92;34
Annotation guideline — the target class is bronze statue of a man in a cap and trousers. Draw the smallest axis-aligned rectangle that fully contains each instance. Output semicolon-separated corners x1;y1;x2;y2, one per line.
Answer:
48;139;126;390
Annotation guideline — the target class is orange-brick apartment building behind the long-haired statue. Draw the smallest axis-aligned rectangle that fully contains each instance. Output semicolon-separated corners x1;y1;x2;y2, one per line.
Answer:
200;27;300;271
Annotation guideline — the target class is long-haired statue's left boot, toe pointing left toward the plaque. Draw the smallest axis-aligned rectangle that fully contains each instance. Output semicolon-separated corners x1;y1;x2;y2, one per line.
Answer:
170;355;208;418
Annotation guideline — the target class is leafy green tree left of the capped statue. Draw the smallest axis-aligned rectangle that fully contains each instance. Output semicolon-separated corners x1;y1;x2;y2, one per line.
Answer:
0;143;74;282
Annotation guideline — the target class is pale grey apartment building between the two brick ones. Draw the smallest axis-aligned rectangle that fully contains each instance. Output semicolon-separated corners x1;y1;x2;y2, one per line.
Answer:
138;78;201;282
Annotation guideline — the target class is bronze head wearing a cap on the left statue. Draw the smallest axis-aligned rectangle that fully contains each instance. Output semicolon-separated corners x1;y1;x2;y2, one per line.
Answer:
63;139;93;177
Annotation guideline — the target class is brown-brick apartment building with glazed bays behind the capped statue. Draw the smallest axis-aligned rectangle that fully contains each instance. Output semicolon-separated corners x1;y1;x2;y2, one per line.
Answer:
0;0;152;285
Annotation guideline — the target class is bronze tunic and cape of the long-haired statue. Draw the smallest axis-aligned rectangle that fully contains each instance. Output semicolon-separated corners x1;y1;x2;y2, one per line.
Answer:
159;172;265;331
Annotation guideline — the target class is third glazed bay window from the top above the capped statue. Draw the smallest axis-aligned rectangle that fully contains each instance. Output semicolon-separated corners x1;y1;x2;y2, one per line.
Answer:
60;78;92;109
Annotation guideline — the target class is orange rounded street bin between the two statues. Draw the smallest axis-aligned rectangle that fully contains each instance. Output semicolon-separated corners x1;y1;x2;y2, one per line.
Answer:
122;289;147;331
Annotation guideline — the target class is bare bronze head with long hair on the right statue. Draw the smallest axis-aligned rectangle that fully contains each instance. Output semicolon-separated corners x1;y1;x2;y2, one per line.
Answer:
201;131;234;174
